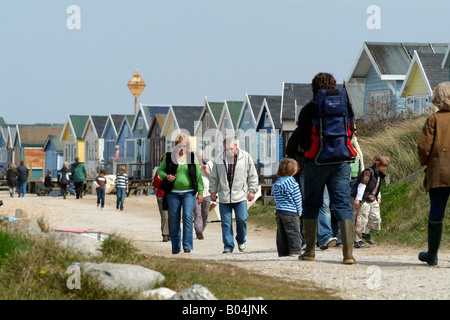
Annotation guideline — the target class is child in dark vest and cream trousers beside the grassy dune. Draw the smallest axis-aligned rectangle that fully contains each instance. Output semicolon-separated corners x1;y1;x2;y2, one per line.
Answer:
351;154;389;248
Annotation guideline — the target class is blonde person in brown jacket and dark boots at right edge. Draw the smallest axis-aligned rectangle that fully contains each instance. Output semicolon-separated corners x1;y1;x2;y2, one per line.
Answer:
417;81;450;265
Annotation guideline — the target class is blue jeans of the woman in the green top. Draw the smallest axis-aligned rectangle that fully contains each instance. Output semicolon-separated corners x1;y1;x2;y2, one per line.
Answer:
167;192;195;254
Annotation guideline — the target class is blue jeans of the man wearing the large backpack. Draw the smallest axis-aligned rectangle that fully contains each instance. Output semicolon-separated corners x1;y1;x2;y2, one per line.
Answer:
302;161;353;221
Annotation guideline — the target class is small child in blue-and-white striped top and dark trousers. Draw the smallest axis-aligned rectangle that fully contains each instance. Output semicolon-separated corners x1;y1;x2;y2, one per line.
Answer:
272;158;302;257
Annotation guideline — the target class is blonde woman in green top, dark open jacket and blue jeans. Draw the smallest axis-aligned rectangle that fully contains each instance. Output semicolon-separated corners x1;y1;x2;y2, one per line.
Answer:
158;133;203;254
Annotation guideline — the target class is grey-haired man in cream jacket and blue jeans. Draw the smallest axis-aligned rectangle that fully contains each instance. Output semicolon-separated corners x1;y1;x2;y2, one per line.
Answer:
209;137;258;253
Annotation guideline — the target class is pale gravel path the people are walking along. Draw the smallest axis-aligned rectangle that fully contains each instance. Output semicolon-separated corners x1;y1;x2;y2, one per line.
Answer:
0;193;450;300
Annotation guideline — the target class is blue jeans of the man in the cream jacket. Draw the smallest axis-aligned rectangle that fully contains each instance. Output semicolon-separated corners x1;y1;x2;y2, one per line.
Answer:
219;200;248;251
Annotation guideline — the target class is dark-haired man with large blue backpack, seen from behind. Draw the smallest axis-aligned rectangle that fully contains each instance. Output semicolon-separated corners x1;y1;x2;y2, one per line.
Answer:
296;73;356;264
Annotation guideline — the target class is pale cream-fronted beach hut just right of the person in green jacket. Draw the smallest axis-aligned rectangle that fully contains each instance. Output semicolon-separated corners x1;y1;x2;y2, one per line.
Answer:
82;115;108;178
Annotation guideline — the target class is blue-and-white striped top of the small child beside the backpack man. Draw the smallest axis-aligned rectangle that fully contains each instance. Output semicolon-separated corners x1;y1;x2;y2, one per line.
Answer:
272;177;302;216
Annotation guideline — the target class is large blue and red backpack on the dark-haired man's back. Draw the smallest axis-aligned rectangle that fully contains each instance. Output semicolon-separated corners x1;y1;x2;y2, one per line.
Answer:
305;89;357;165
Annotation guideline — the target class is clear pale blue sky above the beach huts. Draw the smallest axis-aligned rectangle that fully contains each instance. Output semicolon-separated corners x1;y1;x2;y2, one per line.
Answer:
0;0;450;124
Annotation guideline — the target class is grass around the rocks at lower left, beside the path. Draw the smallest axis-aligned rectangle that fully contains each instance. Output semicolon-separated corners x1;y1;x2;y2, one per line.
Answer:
0;222;334;300
